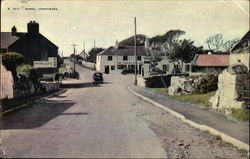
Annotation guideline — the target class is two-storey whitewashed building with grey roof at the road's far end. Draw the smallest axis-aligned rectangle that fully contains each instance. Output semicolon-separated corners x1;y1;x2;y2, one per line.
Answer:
96;42;147;74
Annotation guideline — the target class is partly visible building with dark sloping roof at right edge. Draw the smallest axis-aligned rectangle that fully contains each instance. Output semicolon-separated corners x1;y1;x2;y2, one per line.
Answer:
229;30;250;70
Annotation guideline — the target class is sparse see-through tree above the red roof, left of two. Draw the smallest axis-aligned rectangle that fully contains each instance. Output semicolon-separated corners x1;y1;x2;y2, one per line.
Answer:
206;34;223;51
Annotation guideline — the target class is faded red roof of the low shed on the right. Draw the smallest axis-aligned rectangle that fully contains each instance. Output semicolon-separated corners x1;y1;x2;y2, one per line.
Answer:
195;54;230;67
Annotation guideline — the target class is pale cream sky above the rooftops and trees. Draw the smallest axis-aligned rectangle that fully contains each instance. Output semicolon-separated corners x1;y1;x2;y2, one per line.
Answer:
1;0;249;56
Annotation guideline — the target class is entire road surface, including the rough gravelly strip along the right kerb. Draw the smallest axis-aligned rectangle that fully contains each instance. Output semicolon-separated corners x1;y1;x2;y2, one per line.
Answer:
1;61;246;158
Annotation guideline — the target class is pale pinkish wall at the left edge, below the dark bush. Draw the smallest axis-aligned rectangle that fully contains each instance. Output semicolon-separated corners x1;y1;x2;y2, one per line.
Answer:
0;65;14;99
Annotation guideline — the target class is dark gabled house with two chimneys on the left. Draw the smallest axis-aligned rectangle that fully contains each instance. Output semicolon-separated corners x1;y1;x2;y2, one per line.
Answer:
1;21;59;74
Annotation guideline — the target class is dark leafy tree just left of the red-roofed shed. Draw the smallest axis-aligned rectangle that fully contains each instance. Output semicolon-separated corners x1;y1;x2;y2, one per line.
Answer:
172;39;203;68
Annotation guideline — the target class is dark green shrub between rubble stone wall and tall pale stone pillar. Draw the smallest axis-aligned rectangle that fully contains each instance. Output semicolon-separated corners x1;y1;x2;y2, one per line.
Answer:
195;74;218;93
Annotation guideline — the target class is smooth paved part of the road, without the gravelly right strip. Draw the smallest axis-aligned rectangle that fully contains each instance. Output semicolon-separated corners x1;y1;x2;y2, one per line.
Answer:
2;60;166;158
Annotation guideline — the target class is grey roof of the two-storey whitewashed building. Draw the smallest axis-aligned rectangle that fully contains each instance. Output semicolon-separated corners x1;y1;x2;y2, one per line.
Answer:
98;46;147;56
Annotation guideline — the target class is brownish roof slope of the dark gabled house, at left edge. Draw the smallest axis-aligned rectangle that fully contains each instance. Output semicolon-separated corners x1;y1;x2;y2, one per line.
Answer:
1;32;19;49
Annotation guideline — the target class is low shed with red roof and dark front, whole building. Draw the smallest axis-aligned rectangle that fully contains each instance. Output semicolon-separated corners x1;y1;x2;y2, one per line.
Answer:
192;54;229;73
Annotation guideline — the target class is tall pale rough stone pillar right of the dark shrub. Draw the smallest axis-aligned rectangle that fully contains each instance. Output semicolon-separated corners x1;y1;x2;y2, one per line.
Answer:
209;70;244;110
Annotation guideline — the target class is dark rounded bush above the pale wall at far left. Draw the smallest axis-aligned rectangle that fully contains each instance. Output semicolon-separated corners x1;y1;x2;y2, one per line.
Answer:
3;52;24;81
